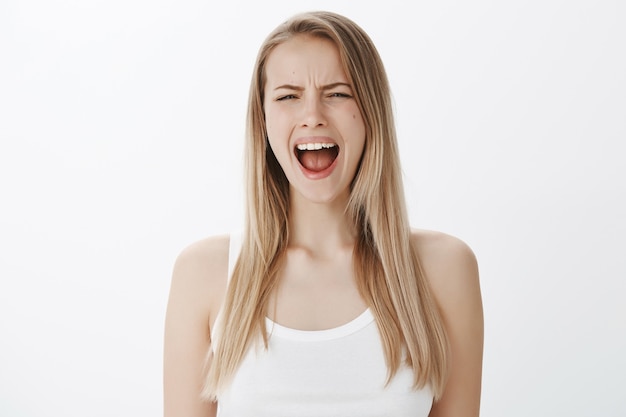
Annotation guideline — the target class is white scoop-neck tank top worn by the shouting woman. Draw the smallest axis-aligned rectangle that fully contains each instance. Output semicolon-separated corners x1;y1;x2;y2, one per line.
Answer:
214;234;433;417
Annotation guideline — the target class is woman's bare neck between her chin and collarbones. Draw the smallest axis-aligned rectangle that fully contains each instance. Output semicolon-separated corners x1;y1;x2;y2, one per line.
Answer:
289;190;356;255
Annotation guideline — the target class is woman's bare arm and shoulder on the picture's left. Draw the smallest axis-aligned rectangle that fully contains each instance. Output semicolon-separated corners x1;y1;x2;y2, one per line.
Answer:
163;238;228;417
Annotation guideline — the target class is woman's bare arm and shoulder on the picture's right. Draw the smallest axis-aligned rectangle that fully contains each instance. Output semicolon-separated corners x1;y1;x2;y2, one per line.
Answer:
418;234;483;417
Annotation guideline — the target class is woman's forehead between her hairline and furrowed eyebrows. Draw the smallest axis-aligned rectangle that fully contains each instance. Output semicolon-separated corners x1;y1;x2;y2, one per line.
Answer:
265;35;348;87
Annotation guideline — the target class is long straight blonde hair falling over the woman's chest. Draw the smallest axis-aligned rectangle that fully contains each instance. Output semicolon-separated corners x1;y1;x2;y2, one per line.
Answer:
203;12;448;399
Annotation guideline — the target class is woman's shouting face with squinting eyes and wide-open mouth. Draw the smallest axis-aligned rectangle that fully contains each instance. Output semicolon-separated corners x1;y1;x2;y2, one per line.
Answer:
264;35;365;203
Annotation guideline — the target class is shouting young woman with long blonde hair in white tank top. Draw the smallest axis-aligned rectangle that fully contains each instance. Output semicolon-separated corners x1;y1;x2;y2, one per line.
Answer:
164;12;483;417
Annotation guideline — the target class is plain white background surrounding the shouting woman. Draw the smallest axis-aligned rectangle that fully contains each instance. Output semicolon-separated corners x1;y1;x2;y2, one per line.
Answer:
0;0;626;417
